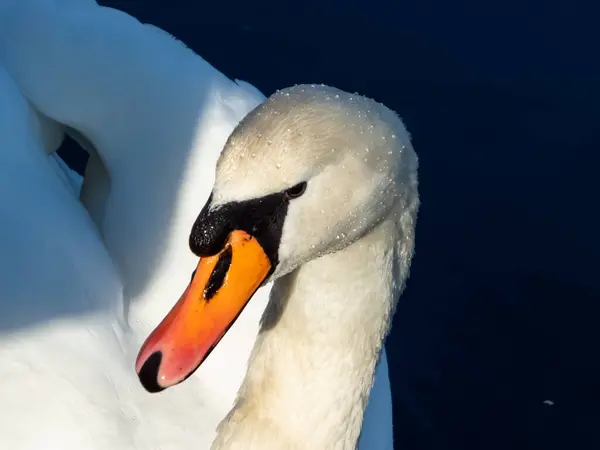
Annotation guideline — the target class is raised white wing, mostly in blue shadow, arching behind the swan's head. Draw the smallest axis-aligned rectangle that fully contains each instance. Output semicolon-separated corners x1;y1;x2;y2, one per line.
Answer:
0;3;264;306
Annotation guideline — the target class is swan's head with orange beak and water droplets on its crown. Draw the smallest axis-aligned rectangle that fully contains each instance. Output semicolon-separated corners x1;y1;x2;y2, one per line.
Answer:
136;85;418;392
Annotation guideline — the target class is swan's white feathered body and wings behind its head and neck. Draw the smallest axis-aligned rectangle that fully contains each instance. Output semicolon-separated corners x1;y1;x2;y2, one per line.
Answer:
0;0;404;450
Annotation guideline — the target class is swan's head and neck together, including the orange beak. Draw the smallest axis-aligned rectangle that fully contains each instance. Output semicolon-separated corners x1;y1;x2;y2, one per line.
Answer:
136;86;419;450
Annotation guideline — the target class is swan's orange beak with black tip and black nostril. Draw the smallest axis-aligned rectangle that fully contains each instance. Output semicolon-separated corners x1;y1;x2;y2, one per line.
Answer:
135;230;271;392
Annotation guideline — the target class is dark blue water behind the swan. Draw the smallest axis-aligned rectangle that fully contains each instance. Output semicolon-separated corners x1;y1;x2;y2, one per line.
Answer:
57;0;600;450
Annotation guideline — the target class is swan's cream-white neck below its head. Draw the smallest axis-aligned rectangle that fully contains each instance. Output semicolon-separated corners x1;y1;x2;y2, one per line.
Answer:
212;221;410;450
